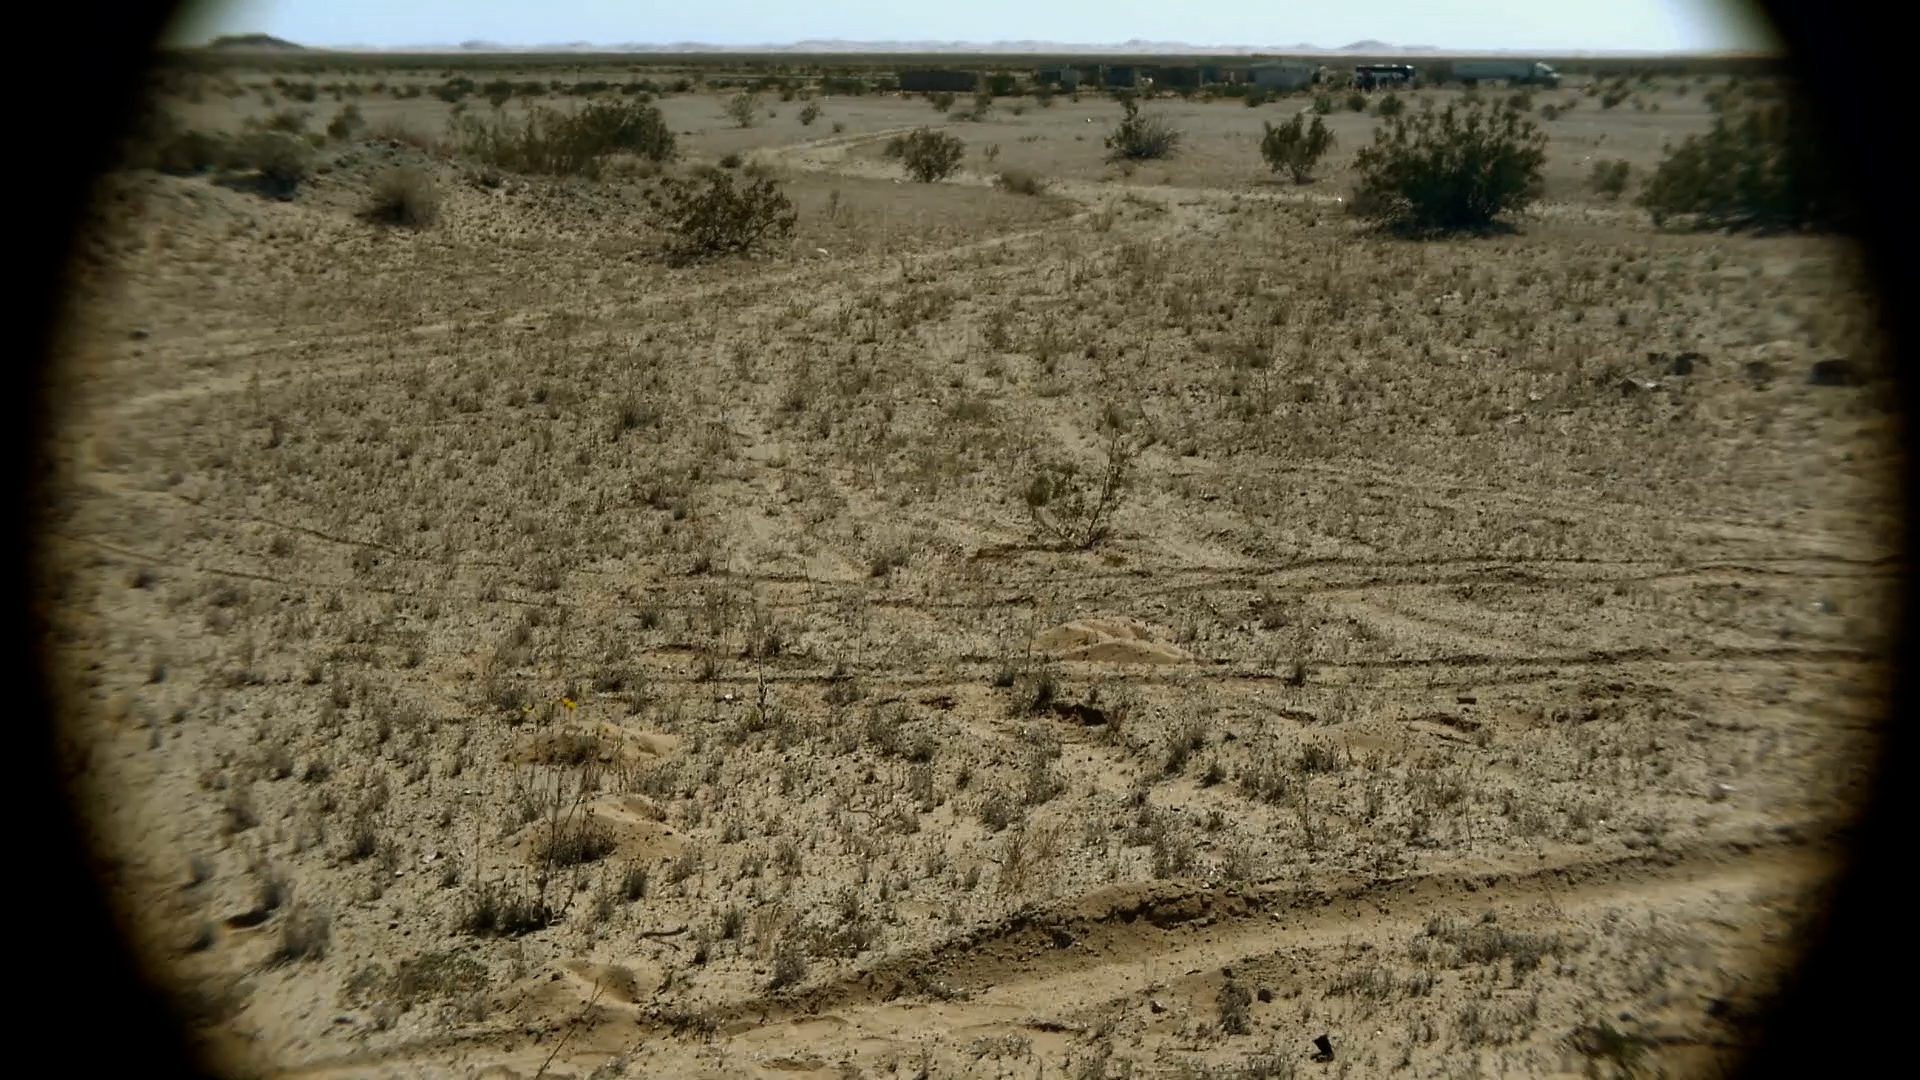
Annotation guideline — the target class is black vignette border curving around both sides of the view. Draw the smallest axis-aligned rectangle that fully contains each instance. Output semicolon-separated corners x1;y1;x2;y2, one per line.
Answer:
0;0;1920;1078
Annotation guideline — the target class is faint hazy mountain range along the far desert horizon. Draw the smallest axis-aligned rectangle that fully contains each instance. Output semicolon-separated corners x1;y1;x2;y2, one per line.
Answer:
207;35;1758;56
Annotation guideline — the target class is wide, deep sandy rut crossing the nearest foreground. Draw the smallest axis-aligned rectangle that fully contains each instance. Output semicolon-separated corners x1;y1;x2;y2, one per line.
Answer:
263;836;1834;1080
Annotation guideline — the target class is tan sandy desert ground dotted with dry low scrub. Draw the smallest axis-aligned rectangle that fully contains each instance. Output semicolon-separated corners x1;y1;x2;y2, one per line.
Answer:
46;61;1901;1078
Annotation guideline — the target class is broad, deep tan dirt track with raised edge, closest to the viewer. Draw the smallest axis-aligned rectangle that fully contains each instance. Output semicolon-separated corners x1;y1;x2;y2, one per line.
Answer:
259;822;1837;1078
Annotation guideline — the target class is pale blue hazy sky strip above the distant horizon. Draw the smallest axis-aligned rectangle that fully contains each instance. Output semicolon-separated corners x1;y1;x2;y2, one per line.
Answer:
175;0;1768;52
